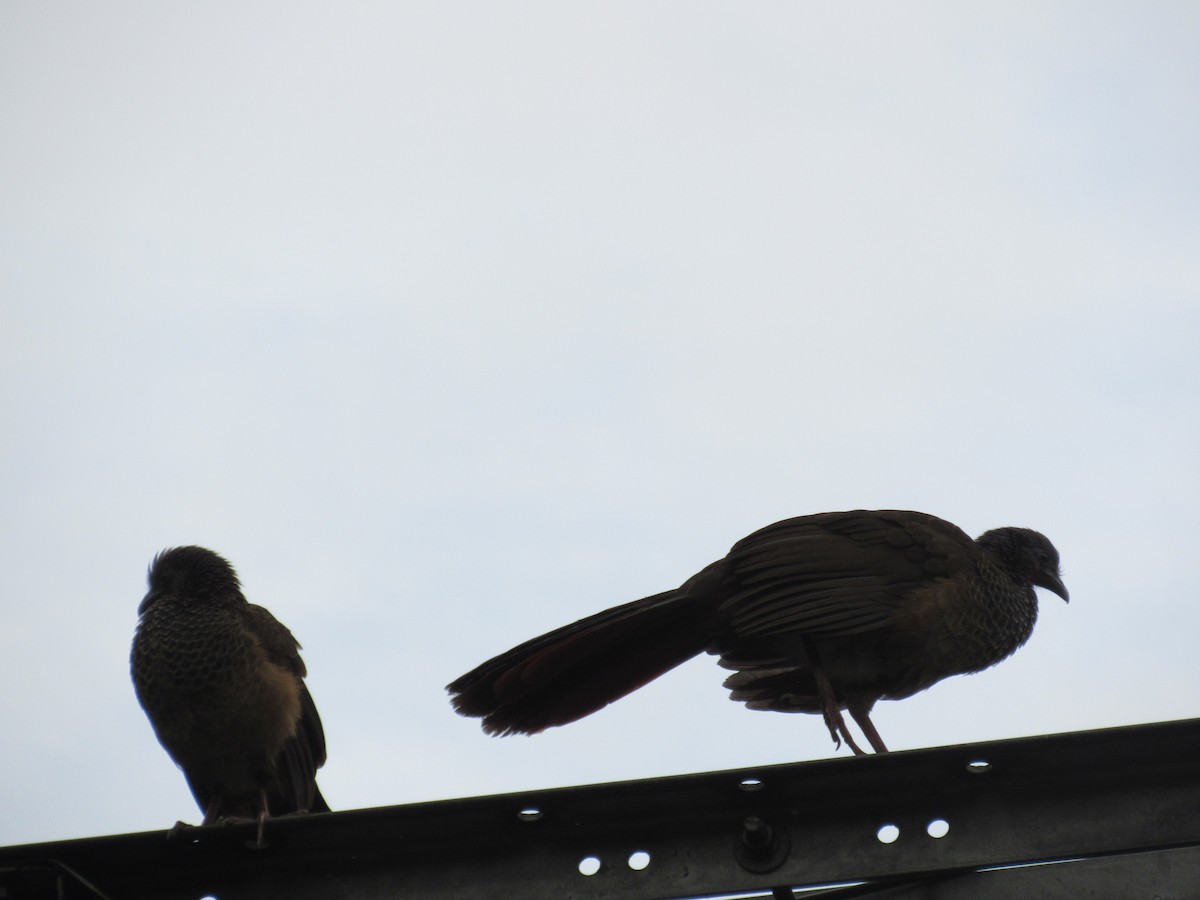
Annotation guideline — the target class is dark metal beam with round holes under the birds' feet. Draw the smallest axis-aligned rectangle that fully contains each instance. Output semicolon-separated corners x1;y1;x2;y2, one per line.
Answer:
0;719;1200;900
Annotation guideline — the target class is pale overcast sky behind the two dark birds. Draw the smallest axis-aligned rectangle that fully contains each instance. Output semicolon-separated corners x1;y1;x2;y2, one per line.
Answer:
0;0;1200;844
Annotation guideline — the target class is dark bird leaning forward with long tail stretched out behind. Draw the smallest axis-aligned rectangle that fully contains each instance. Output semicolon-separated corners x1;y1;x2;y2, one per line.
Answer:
448;510;1068;754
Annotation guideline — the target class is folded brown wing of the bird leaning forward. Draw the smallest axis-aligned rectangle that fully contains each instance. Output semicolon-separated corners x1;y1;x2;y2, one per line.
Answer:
720;510;978;637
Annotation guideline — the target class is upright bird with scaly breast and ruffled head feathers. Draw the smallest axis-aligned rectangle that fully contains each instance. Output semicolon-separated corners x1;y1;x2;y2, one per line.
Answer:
130;547;329;846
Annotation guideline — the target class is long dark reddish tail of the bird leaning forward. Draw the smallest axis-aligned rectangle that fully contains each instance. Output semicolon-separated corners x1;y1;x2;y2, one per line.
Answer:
446;590;710;734
